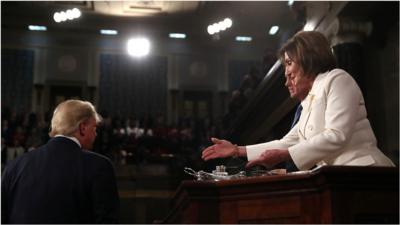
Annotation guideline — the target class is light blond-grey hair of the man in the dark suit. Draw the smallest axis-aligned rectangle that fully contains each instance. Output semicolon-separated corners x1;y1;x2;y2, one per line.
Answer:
49;100;102;137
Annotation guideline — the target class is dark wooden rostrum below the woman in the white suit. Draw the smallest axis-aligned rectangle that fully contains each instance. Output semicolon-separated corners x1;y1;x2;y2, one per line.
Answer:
163;166;399;224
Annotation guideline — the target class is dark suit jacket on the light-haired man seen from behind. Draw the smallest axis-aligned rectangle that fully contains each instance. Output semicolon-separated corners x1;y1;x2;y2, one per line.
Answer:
1;137;119;224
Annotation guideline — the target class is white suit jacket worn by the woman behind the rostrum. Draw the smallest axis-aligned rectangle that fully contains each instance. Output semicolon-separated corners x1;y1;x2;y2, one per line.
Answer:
246;69;394;170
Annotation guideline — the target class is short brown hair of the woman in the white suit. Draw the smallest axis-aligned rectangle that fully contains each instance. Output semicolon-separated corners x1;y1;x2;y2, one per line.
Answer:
278;31;336;76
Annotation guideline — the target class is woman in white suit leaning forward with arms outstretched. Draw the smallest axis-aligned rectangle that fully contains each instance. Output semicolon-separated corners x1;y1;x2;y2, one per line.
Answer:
202;31;394;170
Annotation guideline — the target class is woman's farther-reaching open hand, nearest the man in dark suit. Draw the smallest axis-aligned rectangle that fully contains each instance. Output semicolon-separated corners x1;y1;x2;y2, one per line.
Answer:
201;138;238;161
